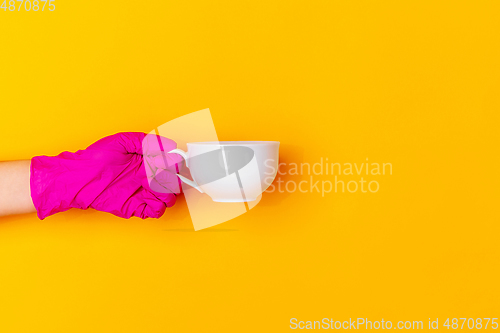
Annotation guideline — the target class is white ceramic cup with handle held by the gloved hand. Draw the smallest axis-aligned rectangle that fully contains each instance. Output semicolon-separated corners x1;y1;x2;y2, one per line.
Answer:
168;141;280;202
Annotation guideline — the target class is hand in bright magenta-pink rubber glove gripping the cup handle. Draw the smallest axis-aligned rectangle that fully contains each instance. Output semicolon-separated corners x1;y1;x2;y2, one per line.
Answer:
30;132;182;219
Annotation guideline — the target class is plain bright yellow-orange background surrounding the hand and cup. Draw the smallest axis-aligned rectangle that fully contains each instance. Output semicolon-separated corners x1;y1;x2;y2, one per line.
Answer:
0;0;500;333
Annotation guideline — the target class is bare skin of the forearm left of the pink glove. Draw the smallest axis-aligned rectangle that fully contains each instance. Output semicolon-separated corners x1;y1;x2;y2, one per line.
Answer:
0;160;36;216
